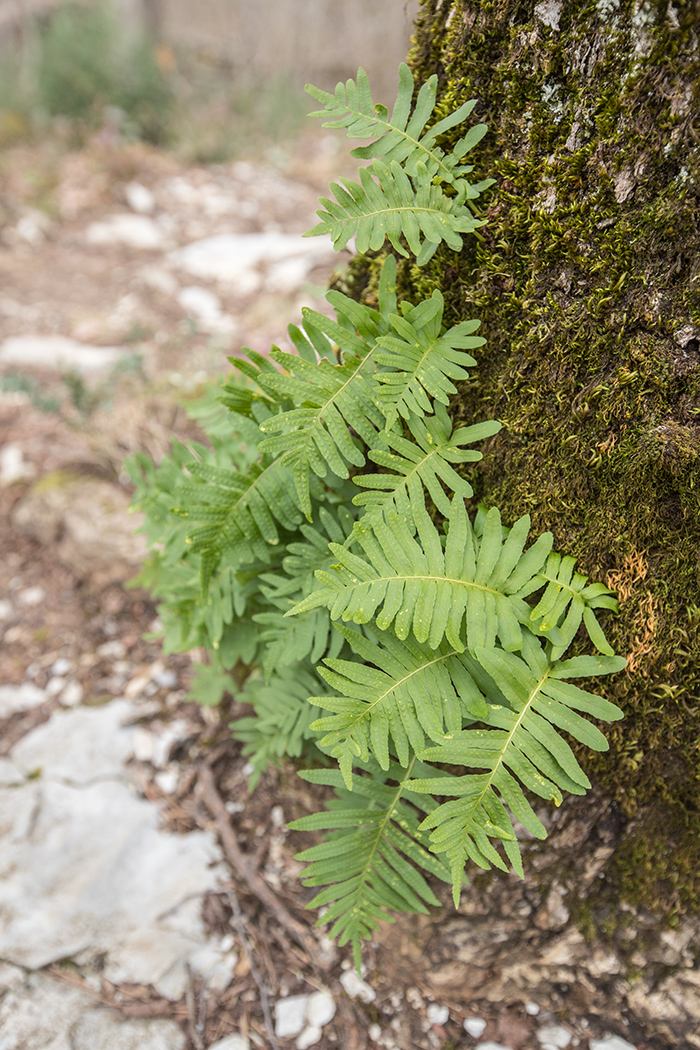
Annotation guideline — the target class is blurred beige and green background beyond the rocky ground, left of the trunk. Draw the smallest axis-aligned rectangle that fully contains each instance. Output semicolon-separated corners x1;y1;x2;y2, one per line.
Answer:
0;0;418;163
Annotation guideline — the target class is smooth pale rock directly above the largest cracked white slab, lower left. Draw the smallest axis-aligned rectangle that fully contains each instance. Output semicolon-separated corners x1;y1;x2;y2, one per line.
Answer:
10;700;135;784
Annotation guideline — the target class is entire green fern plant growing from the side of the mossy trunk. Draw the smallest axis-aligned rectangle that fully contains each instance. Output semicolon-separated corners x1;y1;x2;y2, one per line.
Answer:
131;65;625;967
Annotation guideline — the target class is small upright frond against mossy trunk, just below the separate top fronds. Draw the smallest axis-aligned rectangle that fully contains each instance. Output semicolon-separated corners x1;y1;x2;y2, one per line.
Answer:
375;290;486;423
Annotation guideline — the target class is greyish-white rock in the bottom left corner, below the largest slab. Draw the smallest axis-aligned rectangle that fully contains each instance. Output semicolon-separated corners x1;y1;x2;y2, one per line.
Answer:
0;974;91;1050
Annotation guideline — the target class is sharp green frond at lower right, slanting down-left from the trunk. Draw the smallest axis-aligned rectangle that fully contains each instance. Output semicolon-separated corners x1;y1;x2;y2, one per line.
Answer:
410;635;625;905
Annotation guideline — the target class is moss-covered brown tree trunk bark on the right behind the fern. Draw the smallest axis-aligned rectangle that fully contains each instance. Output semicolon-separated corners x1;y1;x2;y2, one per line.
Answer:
394;0;700;920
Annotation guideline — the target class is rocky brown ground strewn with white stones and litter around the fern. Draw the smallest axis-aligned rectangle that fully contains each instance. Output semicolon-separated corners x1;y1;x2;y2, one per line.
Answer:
0;137;700;1050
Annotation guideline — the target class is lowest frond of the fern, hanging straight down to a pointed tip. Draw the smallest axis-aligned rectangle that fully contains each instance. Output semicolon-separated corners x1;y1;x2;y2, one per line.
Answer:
289;759;449;969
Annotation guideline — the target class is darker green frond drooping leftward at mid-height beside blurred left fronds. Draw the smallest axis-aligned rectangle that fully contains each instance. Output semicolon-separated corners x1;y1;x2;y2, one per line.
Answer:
172;462;302;593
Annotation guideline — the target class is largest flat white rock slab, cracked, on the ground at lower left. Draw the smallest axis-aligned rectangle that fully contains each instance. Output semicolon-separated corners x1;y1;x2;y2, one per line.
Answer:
0;776;218;970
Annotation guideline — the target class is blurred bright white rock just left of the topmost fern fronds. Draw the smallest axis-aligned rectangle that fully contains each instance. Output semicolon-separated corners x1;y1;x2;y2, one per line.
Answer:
168;232;332;295
